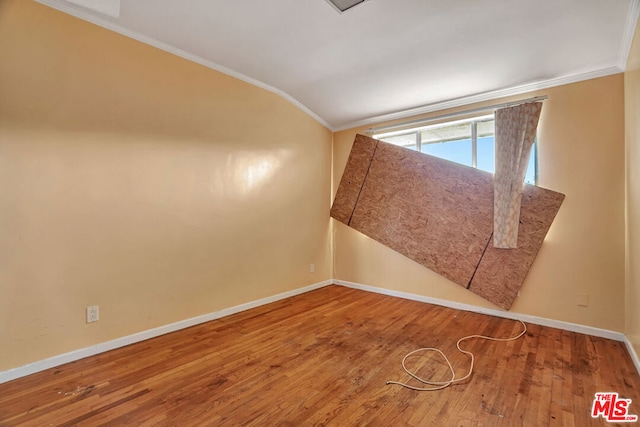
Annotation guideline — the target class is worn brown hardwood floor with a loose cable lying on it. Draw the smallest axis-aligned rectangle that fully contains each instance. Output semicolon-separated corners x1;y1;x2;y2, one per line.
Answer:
0;286;640;426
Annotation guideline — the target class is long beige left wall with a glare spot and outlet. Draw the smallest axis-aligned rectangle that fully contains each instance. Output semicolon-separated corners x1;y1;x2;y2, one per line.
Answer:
0;0;332;371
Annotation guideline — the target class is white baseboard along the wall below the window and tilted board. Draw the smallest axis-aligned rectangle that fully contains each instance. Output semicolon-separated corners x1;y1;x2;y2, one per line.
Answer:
333;280;625;342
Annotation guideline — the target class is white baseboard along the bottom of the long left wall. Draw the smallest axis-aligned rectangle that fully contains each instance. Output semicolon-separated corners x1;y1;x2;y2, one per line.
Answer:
0;280;334;384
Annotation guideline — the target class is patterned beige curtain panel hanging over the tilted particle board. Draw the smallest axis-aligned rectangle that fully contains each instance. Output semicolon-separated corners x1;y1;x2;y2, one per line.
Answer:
493;102;542;249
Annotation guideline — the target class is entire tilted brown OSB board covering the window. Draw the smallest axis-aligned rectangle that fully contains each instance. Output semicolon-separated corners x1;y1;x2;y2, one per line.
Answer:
331;135;564;310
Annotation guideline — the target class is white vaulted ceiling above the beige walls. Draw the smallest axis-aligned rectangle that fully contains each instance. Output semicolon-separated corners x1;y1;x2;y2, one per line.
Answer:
38;0;640;130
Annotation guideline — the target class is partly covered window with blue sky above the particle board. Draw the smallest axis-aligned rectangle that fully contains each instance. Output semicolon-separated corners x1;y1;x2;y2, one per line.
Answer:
374;115;538;185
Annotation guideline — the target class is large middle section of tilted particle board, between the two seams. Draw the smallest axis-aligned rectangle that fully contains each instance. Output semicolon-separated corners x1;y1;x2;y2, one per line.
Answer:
349;142;493;287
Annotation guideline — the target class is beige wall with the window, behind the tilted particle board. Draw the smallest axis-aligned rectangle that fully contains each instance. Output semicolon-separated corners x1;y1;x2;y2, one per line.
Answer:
333;74;625;332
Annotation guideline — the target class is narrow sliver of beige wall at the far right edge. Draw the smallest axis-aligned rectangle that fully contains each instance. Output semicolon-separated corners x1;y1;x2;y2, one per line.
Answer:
624;19;640;354
